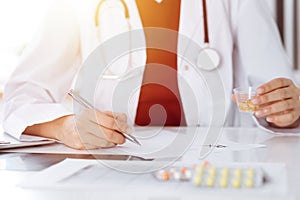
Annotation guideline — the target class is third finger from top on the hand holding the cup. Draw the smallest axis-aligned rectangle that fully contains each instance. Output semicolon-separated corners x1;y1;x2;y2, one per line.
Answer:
255;99;299;117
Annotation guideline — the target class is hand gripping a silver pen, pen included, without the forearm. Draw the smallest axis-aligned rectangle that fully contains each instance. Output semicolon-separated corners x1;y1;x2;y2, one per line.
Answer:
68;90;140;148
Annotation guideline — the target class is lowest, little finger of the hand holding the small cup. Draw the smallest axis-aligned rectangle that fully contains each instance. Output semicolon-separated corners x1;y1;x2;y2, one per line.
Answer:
266;110;299;127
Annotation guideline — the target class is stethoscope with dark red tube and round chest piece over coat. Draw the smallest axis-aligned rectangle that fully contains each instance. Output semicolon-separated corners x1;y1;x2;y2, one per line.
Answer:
95;0;221;71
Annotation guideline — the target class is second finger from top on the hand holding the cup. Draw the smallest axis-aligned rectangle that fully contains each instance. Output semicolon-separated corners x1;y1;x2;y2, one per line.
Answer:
251;87;294;105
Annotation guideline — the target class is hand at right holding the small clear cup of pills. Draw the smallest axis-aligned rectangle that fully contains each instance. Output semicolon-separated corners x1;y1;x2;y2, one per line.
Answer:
252;78;300;128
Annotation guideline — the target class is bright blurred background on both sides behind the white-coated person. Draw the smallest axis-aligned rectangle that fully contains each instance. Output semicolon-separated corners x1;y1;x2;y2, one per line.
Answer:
0;0;300;97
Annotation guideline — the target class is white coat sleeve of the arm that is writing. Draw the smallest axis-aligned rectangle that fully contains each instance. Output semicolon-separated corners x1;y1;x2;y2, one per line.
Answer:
3;0;80;139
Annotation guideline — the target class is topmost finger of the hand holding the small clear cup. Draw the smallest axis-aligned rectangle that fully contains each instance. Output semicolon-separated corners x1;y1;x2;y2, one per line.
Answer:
256;78;293;95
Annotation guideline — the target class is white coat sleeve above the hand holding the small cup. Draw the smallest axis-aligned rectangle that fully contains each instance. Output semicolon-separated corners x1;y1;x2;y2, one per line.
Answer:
232;0;293;86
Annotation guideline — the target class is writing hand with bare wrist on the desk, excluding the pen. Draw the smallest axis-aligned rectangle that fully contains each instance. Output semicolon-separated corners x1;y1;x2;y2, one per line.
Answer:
24;109;131;149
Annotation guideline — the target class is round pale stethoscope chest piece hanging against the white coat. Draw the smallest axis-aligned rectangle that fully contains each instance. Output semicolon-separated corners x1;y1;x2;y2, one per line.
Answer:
197;48;221;71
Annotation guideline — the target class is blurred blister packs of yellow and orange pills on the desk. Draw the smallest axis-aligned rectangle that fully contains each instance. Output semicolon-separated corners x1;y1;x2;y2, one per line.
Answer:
154;162;265;189
